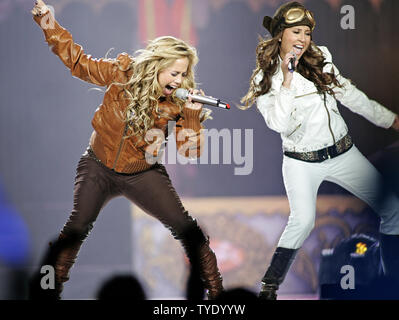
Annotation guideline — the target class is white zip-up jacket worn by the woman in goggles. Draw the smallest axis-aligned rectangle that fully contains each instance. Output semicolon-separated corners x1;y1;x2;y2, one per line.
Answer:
254;47;396;152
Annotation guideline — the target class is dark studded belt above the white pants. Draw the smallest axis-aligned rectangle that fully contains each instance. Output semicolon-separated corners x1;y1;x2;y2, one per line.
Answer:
284;134;353;162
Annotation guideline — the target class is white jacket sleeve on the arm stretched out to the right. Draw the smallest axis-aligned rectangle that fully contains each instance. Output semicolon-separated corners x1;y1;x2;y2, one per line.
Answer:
319;47;396;128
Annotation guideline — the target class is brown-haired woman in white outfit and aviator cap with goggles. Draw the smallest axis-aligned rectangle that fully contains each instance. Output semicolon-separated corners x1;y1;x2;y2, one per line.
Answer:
241;2;399;299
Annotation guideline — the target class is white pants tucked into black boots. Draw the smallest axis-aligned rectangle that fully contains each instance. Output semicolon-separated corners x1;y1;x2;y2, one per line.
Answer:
278;146;399;249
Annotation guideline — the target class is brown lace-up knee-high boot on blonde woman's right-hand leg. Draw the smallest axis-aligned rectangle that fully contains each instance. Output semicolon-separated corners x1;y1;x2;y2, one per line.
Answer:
175;220;223;300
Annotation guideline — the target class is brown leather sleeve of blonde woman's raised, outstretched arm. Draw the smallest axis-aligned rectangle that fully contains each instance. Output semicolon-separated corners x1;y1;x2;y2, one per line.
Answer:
33;11;131;86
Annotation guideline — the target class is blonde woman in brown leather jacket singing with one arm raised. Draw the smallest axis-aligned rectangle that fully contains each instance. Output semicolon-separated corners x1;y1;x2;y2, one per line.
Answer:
32;0;223;299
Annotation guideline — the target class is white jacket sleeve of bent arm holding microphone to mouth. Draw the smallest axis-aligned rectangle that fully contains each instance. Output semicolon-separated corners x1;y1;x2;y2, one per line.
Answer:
256;84;296;134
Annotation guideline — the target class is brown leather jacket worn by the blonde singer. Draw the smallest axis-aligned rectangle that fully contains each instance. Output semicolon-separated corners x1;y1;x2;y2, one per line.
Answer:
34;13;203;173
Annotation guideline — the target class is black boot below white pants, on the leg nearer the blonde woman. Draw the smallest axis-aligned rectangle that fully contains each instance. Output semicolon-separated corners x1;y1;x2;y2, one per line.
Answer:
259;247;298;300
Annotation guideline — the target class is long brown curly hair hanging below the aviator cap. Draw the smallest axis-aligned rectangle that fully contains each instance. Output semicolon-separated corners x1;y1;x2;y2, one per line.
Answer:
241;30;342;110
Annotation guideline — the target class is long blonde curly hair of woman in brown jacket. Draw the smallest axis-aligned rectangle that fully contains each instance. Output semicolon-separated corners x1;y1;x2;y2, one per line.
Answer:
117;36;211;141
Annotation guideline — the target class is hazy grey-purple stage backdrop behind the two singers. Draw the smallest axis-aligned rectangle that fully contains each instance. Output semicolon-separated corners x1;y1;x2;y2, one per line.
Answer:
0;0;399;298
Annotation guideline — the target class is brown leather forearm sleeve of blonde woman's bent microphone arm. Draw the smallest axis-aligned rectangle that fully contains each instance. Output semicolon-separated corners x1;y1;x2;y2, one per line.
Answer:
175;107;204;158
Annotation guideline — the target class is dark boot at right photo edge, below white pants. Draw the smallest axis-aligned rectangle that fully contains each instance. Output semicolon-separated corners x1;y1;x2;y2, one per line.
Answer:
380;233;399;284
